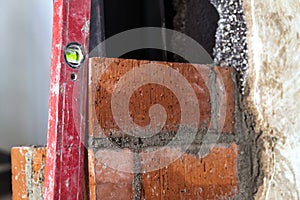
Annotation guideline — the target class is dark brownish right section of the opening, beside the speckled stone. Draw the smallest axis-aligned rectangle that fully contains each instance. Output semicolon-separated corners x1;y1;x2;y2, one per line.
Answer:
172;0;220;62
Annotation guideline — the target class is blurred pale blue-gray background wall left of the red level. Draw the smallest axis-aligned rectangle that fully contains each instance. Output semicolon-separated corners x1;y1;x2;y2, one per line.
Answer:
0;0;53;151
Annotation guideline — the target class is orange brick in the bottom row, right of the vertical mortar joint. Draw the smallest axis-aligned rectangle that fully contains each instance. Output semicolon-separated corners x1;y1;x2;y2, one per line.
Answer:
141;144;239;200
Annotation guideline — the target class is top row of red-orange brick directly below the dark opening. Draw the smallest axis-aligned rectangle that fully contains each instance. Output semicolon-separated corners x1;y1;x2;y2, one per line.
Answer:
89;58;234;138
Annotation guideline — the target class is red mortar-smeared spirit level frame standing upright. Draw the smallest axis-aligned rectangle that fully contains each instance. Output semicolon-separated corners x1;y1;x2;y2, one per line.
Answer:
44;0;91;200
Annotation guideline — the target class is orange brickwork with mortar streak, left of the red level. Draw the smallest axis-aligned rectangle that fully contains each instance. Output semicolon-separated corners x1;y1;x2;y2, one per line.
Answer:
11;147;46;199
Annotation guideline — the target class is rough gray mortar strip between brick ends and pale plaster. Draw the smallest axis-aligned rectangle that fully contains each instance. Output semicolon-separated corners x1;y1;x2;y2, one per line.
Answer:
232;70;263;200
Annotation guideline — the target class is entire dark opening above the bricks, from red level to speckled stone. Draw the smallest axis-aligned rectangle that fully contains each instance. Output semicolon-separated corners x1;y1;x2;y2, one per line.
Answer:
90;0;219;62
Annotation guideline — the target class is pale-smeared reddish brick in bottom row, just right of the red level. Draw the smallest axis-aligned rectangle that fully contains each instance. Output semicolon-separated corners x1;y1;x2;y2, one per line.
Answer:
89;150;135;200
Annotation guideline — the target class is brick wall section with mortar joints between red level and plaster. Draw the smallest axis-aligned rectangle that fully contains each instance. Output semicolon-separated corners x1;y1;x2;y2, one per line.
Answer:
89;58;257;199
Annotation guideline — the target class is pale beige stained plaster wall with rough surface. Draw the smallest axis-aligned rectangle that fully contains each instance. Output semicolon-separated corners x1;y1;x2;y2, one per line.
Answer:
244;0;300;200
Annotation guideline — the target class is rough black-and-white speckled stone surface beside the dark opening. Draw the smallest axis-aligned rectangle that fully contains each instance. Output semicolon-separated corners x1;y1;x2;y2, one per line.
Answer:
211;0;248;71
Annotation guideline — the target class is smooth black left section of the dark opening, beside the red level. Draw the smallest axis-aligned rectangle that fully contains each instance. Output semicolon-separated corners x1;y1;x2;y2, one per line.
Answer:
90;0;167;61
